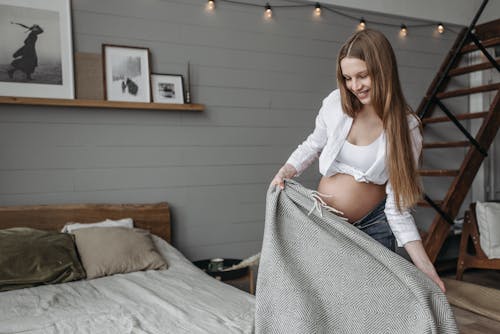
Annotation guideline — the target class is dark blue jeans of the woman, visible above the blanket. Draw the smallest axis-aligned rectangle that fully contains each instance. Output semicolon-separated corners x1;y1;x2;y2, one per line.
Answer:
352;199;396;252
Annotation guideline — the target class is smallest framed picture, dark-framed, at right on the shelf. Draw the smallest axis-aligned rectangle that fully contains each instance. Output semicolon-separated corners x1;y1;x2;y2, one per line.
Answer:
151;74;184;104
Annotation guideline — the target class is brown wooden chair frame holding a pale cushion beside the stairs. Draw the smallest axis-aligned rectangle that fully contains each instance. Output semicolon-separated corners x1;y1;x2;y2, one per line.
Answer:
456;201;500;280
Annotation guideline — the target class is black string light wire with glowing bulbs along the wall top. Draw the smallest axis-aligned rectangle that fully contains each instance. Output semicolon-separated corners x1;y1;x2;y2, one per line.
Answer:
206;0;457;37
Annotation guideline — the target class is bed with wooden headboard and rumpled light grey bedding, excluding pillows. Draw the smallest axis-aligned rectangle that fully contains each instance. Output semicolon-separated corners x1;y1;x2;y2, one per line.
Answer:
0;203;255;334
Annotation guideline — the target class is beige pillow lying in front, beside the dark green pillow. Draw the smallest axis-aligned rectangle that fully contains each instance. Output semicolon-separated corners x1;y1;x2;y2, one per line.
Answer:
74;227;167;279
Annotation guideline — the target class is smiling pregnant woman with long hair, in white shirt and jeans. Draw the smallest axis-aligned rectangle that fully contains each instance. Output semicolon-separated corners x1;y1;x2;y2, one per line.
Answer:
271;30;445;291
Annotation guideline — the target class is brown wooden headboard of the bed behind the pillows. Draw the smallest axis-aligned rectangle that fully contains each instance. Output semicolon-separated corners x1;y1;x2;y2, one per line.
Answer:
0;202;171;242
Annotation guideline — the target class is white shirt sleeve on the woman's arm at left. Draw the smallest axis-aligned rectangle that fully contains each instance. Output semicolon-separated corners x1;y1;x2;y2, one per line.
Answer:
287;99;328;176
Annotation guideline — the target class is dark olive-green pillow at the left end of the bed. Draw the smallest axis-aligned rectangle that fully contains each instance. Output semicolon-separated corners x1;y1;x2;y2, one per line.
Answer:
0;227;85;291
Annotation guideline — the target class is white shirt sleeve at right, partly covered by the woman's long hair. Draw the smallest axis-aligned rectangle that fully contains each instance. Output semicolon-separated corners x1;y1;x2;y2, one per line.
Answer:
384;116;422;247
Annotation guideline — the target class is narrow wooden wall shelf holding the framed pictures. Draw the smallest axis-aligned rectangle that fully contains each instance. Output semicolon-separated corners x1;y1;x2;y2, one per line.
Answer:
0;96;205;111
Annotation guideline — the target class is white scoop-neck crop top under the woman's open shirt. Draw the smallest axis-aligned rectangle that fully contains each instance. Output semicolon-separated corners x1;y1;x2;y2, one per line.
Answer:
335;135;382;174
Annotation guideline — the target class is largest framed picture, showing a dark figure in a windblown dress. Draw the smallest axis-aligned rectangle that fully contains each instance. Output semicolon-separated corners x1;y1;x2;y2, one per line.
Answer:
0;0;75;99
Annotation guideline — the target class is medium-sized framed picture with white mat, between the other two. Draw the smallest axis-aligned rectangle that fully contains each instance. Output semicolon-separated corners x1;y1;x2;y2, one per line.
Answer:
102;44;151;102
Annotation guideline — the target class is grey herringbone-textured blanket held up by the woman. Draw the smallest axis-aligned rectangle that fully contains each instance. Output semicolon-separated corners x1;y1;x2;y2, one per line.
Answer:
255;181;458;334
